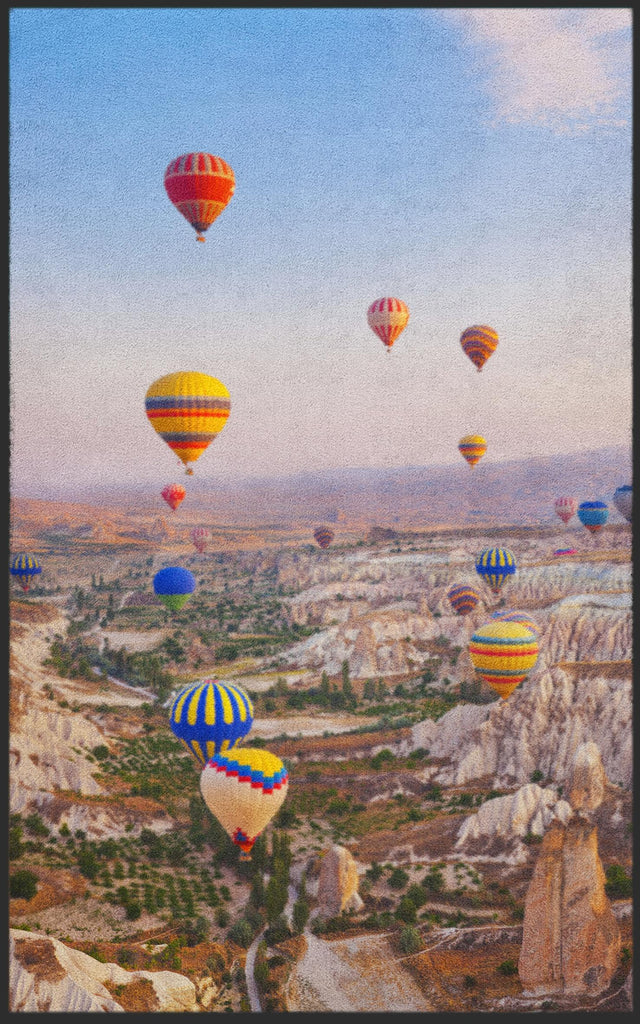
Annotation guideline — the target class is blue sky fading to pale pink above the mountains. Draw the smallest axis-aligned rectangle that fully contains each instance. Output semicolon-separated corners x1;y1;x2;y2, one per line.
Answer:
9;7;632;497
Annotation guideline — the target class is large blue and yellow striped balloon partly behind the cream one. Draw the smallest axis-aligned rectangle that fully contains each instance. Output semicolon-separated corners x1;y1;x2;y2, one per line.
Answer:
169;679;253;767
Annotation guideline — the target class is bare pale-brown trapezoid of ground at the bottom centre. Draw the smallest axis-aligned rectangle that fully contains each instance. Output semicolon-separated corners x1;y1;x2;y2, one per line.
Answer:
287;930;433;1013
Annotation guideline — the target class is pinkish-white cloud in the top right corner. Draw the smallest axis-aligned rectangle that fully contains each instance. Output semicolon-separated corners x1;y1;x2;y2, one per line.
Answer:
441;7;632;133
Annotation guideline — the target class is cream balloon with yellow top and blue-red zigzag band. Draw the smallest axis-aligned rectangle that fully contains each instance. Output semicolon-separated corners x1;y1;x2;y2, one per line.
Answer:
200;746;289;860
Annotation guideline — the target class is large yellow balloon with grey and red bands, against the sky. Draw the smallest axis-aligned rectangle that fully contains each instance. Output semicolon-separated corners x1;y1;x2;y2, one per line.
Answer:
144;371;231;476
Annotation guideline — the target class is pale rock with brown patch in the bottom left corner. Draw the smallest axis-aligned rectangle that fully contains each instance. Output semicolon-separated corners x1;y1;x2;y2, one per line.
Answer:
9;929;198;1013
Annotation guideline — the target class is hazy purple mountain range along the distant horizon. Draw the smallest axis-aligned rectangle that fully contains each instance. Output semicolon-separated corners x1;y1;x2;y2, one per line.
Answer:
12;445;632;528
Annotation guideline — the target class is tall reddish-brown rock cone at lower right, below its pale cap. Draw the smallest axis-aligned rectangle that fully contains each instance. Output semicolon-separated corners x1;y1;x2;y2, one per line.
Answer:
518;815;621;995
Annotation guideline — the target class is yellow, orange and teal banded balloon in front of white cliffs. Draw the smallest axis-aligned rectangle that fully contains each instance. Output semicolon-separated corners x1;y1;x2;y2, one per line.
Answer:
469;618;539;698
